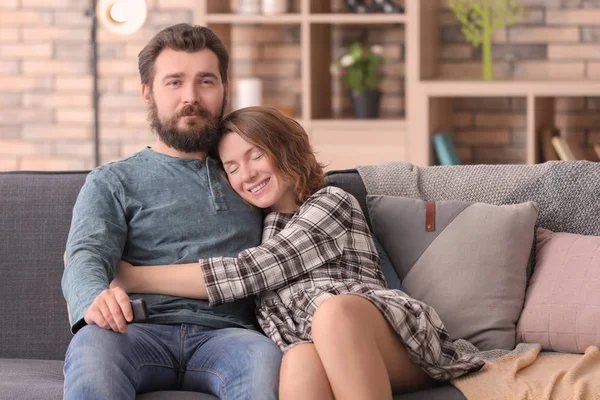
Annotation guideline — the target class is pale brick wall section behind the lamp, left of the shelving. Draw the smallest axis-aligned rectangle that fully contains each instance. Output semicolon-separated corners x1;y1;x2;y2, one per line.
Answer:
0;0;193;170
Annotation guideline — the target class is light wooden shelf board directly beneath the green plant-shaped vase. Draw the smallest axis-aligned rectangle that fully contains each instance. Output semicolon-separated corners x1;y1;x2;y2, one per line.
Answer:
419;80;600;97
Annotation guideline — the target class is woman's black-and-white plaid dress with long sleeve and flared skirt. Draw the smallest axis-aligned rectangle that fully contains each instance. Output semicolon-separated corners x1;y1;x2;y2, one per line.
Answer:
200;187;483;380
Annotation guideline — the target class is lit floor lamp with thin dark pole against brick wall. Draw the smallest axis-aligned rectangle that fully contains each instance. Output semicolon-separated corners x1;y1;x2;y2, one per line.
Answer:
86;0;148;167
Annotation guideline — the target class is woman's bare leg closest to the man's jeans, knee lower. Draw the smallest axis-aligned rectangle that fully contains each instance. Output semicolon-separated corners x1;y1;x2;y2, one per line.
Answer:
279;343;333;400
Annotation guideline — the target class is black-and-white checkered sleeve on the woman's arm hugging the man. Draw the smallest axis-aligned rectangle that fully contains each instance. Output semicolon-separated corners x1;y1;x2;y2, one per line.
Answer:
200;188;352;305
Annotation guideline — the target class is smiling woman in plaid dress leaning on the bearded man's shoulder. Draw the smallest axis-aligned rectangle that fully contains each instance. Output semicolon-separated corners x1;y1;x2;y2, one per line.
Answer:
113;107;483;400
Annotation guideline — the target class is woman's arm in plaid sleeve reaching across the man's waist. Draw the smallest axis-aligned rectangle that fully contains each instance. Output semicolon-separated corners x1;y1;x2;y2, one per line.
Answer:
111;190;353;305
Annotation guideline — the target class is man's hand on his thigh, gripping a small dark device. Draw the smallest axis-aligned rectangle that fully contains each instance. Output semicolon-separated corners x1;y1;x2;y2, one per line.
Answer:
83;287;133;333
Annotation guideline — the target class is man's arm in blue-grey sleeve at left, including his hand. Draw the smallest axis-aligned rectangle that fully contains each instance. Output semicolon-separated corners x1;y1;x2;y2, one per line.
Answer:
62;170;131;333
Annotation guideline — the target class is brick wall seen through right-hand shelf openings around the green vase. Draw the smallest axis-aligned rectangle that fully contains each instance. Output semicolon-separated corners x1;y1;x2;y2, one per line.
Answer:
440;0;600;163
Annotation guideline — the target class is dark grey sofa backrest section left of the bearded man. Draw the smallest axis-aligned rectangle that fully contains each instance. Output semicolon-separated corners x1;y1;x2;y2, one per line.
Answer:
0;172;88;360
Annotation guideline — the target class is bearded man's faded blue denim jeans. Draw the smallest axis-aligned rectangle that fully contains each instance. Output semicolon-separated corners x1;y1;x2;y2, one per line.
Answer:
64;324;281;400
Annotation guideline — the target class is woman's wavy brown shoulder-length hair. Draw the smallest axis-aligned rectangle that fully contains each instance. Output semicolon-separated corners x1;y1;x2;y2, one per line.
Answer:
221;107;324;205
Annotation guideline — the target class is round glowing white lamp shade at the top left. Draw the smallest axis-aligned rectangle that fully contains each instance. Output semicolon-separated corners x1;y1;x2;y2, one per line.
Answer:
96;0;148;35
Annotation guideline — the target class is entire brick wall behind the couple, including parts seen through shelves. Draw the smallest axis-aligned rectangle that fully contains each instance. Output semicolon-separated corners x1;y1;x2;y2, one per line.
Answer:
0;0;600;170
